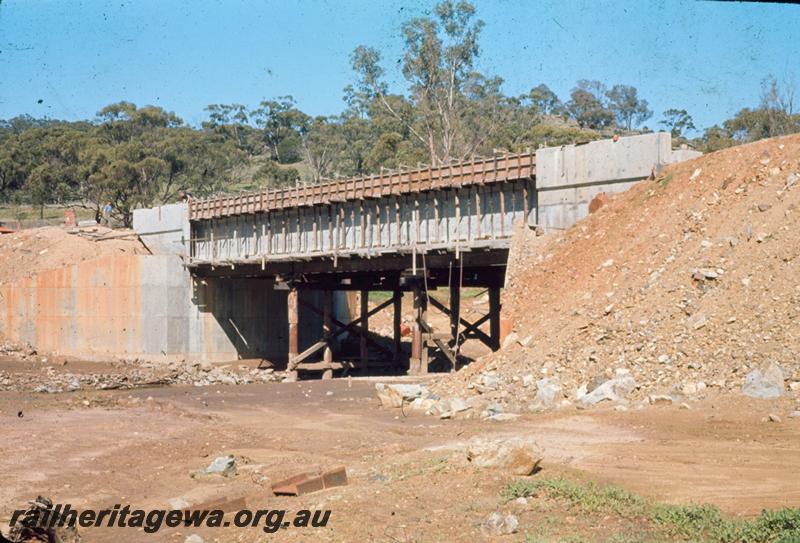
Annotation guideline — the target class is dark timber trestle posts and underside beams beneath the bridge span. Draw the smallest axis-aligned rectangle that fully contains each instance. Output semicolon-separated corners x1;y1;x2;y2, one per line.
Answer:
192;248;508;378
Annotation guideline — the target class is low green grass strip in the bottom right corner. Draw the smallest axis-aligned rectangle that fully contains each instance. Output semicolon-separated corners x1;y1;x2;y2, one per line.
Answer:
501;478;800;543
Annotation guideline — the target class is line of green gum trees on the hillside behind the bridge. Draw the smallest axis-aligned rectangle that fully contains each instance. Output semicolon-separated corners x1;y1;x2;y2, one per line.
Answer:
0;0;800;225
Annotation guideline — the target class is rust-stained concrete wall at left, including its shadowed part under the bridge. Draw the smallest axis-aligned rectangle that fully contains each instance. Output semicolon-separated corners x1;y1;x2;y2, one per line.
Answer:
0;255;322;361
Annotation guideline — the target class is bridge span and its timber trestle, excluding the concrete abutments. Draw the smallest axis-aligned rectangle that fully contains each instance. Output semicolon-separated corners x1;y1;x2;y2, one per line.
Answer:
189;151;536;372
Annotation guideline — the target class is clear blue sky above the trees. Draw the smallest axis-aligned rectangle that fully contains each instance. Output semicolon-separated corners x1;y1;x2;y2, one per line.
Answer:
0;0;800;134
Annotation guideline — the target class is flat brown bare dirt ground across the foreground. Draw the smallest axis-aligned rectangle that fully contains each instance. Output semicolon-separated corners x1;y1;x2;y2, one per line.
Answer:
0;370;800;541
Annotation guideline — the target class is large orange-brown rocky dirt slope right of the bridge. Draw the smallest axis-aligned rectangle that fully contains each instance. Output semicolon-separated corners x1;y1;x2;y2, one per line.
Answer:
437;136;800;405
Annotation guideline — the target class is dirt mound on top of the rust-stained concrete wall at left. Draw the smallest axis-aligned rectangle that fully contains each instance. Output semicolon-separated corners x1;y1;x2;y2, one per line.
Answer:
0;226;149;283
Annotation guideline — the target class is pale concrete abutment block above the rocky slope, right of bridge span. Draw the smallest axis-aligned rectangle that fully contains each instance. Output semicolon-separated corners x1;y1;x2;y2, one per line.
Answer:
531;132;701;229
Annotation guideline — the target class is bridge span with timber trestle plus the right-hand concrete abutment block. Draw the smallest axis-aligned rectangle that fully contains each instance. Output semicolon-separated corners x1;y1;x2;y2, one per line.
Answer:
172;133;691;376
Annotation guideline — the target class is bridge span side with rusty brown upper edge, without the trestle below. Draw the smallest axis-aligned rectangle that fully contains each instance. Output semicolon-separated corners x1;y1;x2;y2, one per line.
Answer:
189;152;536;265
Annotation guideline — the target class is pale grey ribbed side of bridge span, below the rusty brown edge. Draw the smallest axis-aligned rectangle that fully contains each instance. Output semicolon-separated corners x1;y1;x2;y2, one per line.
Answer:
190;180;536;265
